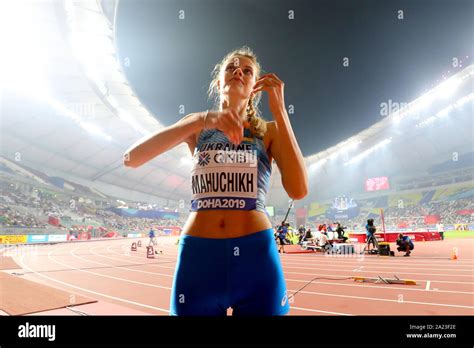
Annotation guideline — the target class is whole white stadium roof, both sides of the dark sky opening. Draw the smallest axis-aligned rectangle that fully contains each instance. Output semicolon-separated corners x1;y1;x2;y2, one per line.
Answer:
0;0;474;206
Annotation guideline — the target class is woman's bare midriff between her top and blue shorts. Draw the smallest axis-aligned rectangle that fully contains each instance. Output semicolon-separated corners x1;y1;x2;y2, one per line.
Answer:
182;210;272;238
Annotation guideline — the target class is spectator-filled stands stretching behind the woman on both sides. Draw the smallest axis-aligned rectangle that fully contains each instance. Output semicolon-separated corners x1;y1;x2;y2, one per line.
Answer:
0;175;474;232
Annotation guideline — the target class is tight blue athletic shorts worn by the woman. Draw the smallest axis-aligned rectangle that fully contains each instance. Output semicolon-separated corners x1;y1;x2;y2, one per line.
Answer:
170;228;290;316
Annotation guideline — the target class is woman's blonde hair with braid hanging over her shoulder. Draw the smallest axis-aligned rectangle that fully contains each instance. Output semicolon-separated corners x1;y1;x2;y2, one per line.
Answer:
208;46;267;138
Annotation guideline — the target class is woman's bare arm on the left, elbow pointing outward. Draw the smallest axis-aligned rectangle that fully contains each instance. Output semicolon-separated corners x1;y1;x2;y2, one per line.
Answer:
123;111;206;168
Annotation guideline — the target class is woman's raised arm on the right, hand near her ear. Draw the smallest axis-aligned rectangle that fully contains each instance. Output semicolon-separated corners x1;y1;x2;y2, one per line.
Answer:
253;74;308;199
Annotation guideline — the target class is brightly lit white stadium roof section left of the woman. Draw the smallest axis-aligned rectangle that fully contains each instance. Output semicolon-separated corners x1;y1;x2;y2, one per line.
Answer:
0;1;189;204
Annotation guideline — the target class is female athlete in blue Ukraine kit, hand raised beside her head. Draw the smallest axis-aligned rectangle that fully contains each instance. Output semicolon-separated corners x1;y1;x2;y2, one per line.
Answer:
124;46;308;316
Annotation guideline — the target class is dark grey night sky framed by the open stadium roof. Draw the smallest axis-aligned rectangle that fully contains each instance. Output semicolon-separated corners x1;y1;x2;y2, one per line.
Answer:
116;0;474;156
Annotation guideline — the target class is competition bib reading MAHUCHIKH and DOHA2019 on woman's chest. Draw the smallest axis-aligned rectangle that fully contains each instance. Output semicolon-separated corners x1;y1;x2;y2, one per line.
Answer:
191;143;258;211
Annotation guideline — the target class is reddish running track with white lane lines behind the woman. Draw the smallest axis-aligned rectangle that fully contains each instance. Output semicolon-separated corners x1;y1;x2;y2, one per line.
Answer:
5;237;474;315
